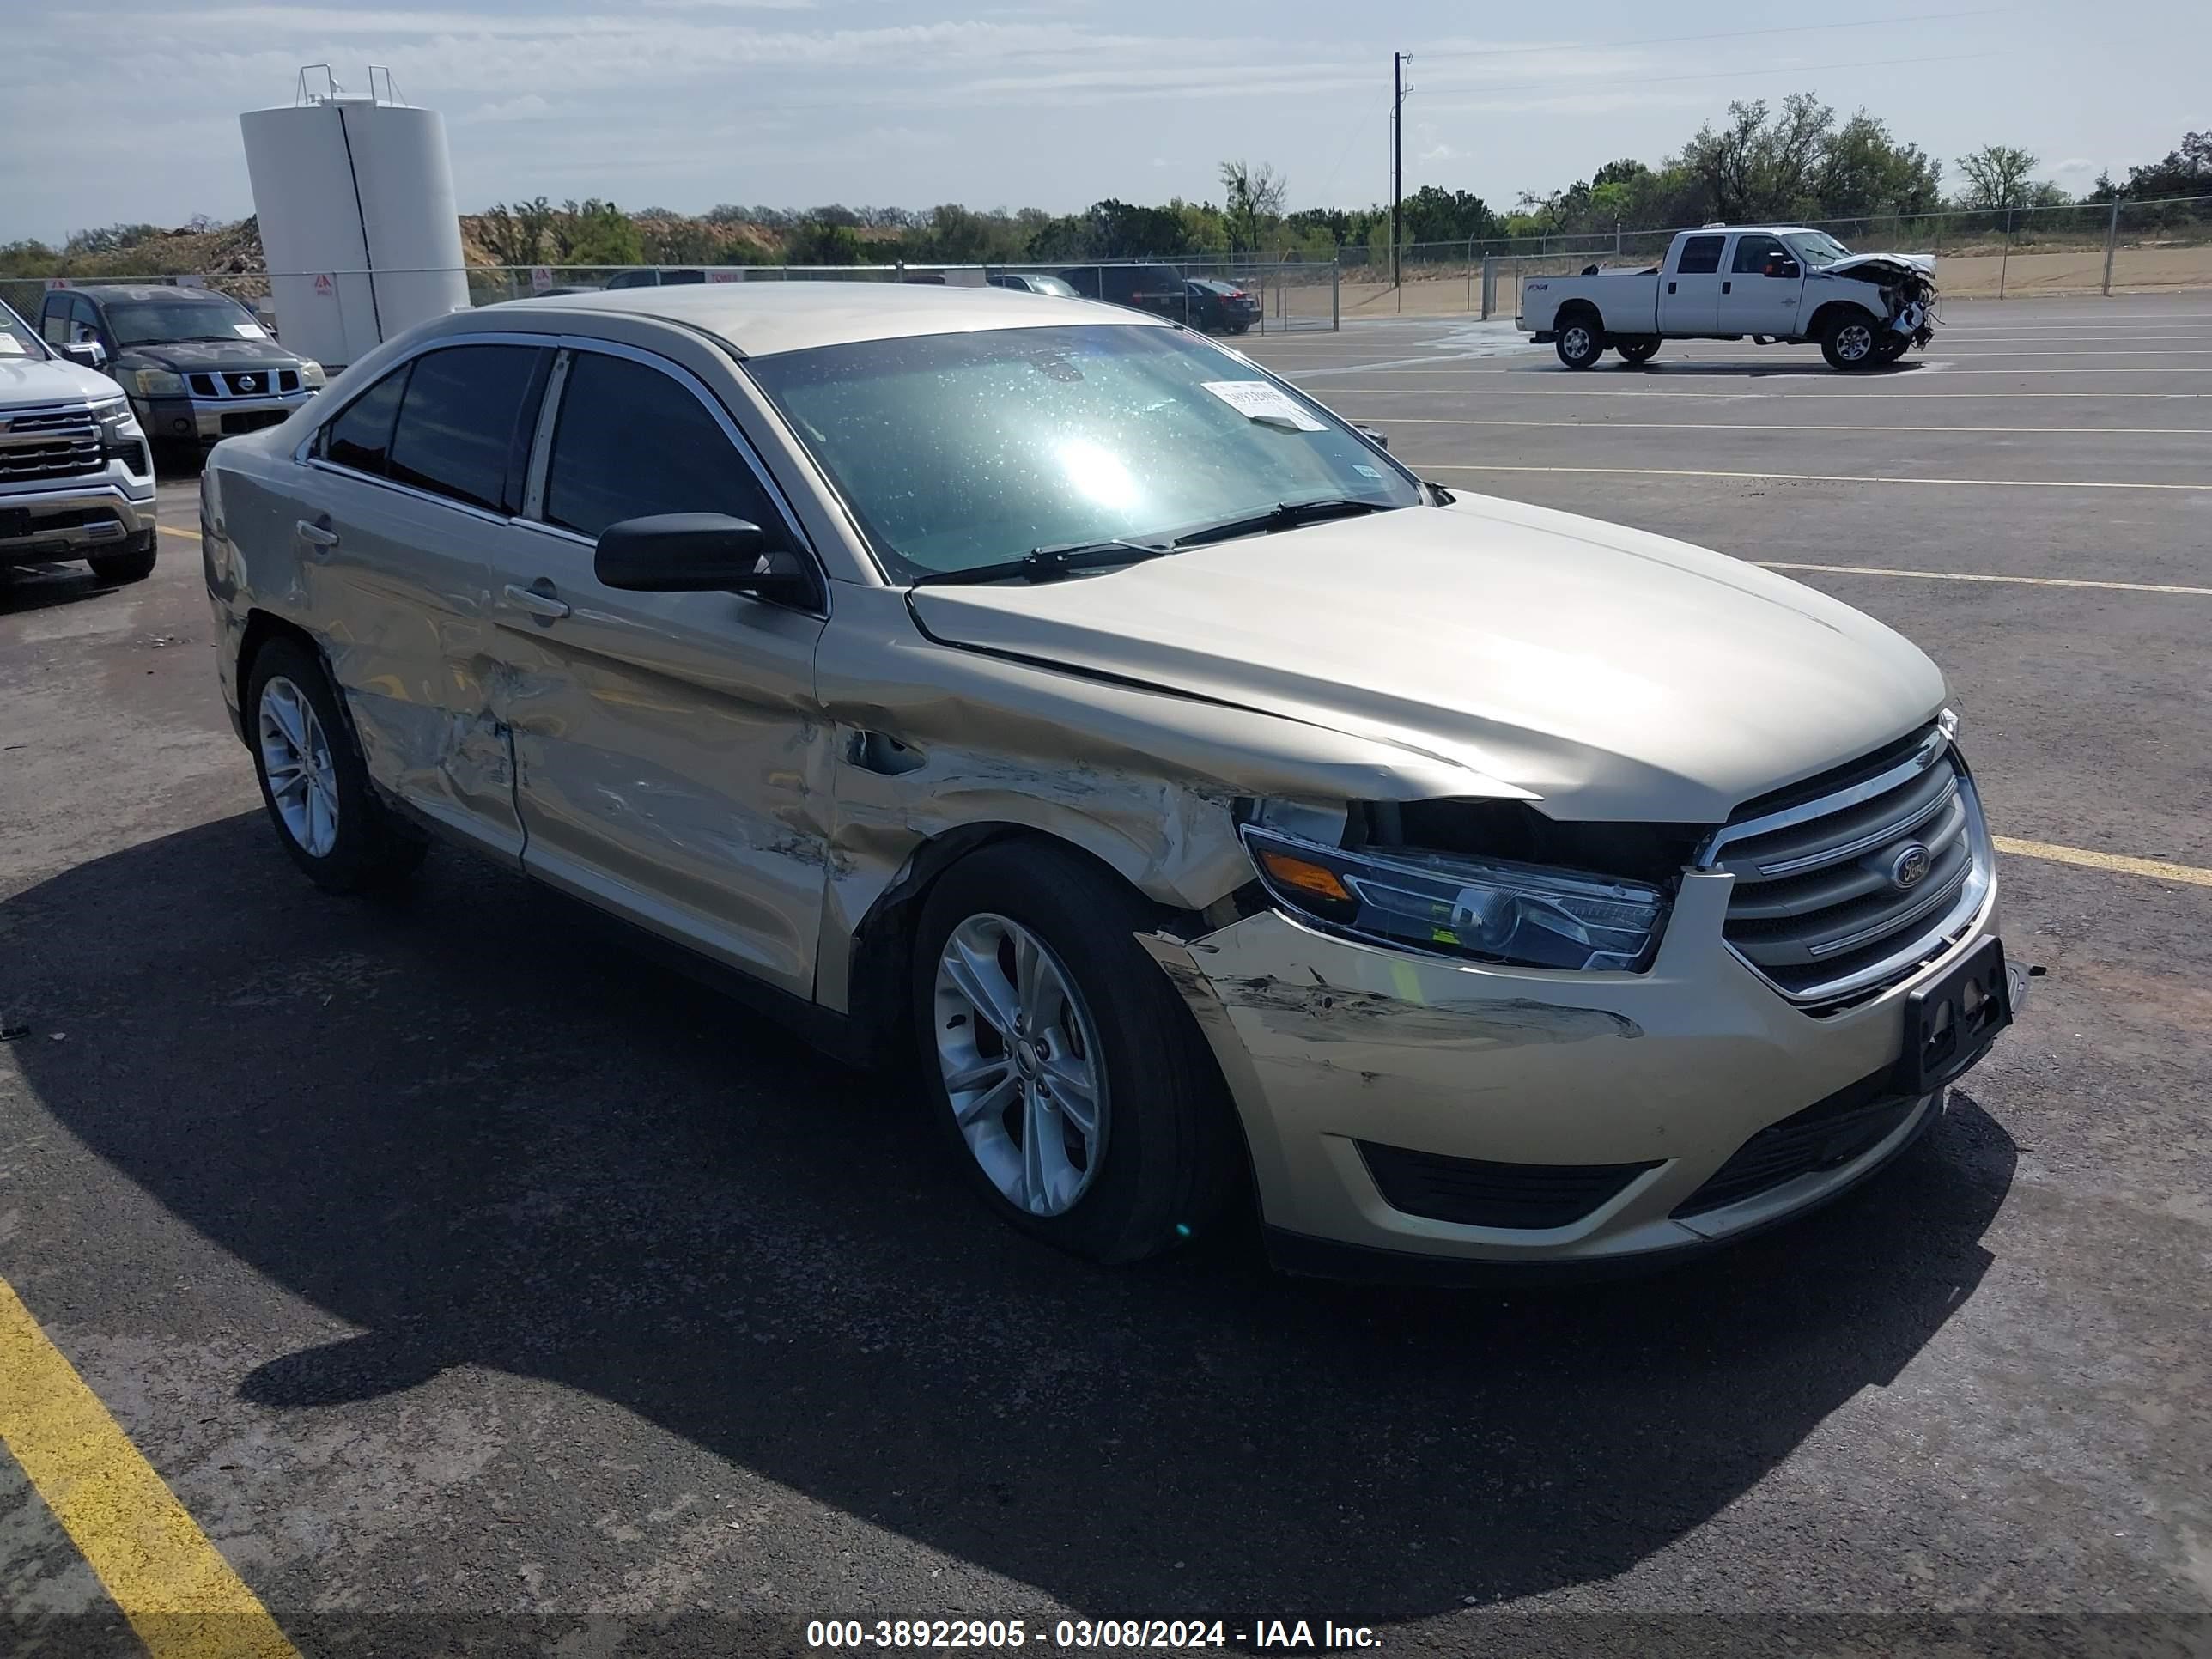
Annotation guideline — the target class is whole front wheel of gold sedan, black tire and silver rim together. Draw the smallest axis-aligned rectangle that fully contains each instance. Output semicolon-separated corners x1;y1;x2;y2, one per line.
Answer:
911;841;1241;1263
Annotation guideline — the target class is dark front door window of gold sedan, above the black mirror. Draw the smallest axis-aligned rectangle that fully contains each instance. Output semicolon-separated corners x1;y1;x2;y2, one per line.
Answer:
544;352;783;544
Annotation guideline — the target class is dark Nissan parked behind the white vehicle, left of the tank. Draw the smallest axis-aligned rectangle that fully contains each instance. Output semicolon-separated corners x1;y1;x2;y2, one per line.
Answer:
40;283;323;455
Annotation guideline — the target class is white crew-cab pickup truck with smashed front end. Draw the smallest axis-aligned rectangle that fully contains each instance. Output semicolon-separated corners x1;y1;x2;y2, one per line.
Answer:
1516;226;1936;369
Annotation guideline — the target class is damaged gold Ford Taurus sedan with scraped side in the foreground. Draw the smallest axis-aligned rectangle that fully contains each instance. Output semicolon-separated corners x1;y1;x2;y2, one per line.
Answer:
201;281;2015;1274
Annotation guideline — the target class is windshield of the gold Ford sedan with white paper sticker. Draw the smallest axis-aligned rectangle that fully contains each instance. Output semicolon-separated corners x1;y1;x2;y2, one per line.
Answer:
745;323;1420;581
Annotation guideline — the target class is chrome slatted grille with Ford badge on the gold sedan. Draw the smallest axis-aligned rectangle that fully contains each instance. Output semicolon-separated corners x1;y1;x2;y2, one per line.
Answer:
1704;728;1993;1002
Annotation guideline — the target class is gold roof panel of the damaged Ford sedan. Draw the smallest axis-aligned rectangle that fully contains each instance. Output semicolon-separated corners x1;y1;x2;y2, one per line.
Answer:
487;281;1172;356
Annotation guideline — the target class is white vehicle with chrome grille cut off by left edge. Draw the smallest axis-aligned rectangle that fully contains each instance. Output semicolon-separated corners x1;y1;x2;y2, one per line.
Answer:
0;303;155;581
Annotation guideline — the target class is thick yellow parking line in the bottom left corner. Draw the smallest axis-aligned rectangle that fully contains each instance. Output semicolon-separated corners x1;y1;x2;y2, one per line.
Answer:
0;1281;299;1659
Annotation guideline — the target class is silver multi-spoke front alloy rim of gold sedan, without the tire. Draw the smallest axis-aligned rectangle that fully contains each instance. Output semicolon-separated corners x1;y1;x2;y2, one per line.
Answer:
933;914;1109;1217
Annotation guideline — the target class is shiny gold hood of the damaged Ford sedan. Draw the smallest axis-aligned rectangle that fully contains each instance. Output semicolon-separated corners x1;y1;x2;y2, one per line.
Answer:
909;495;1944;823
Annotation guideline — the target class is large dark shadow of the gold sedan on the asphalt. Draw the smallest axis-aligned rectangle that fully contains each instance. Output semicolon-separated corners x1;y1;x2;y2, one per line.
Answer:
0;814;2015;1624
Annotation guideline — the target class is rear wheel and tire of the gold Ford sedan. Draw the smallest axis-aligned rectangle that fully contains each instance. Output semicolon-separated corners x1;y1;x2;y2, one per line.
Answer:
246;639;427;894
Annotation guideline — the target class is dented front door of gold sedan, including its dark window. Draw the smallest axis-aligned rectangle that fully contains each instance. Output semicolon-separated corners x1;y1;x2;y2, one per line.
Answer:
491;343;830;995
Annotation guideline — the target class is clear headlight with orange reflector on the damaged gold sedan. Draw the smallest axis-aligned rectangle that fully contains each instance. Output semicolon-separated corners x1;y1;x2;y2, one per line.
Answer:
1243;825;1666;969
